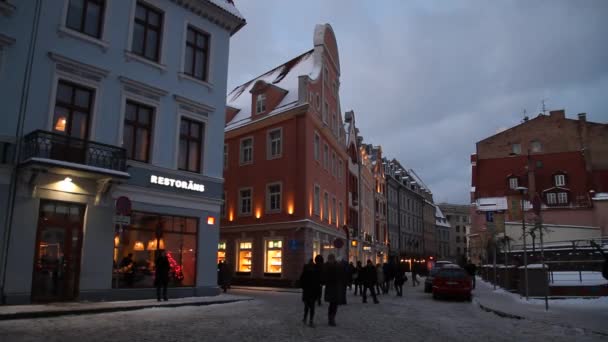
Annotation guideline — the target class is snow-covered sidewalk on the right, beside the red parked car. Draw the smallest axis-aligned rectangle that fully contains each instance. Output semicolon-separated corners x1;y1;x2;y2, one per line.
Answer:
473;277;608;336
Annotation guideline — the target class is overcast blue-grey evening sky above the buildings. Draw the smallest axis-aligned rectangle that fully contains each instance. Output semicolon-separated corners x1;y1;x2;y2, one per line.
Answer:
228;0;608;203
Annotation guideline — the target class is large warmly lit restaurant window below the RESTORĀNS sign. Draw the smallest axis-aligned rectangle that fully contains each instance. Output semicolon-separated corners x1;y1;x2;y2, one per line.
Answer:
112;212;198;288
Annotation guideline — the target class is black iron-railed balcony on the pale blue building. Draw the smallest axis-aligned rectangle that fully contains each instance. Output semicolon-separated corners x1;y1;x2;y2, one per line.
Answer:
21;130;129;177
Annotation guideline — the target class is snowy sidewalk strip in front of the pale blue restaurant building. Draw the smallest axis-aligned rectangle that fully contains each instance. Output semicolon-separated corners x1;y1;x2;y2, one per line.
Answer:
0;294;252;321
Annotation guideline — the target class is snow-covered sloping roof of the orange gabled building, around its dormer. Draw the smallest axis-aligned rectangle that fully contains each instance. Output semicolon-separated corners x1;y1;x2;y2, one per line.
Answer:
226;49;322;131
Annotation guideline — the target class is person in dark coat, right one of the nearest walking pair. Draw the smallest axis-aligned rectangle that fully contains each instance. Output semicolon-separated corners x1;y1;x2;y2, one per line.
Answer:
322;254;346;327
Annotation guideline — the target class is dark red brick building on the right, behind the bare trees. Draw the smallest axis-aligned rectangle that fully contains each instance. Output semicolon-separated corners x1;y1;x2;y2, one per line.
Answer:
469;110;608;261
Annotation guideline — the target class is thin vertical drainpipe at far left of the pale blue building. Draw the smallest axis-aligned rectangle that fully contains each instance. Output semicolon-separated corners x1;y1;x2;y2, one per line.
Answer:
0;0;42;304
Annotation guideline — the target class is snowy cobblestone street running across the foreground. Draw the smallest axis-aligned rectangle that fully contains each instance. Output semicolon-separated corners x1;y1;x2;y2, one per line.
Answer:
0;286;605;342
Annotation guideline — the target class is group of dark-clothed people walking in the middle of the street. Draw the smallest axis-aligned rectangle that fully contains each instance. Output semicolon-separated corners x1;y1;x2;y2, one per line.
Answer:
300;254;417;327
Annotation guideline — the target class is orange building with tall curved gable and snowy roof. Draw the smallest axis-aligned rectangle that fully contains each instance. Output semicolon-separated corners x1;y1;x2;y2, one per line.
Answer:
218;24;348;285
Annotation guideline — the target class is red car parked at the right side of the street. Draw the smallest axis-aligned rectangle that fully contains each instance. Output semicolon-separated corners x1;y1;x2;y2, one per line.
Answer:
433;265;473;300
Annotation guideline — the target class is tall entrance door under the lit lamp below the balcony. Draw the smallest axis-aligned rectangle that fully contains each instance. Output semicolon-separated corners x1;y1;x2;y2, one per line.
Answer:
32;201;85;302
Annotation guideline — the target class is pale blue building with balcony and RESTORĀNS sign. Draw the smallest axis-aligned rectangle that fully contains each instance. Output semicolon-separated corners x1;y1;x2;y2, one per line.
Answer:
0;0;245;303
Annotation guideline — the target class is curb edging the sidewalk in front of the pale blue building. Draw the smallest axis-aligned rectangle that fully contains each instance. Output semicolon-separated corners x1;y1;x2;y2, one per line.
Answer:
0;298;253;321
